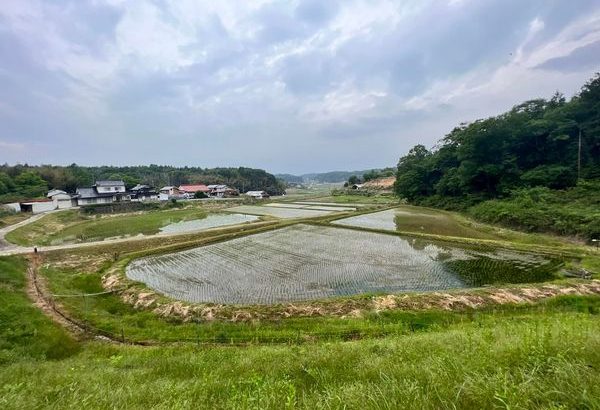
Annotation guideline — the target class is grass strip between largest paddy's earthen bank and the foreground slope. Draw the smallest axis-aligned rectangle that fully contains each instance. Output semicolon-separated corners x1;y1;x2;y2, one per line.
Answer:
37;258;600;344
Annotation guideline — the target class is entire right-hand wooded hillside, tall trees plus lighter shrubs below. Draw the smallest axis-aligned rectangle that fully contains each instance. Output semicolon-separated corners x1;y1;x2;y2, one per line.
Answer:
395;74;600;238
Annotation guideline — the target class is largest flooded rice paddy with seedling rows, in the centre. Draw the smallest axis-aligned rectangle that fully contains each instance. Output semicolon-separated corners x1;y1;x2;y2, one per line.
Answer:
126;225;559;304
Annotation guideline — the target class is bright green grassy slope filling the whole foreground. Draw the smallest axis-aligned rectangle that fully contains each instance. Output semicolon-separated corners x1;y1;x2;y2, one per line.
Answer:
0;258;600;409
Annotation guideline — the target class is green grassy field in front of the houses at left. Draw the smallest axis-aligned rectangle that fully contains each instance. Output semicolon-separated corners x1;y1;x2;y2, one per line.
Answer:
6;207;207;246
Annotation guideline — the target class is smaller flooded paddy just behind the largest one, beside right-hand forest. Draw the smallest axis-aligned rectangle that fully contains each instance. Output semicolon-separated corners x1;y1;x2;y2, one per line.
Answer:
332;206;498;239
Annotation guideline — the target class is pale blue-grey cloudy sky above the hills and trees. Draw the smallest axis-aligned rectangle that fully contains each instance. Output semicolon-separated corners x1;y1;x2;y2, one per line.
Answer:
0;0;600;174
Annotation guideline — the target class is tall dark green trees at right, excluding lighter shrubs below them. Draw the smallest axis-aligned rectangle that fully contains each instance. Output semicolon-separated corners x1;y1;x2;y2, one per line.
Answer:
395;73;600;209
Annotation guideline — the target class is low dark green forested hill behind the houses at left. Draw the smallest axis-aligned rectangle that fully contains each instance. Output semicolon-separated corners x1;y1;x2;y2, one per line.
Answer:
0;164;285;202
